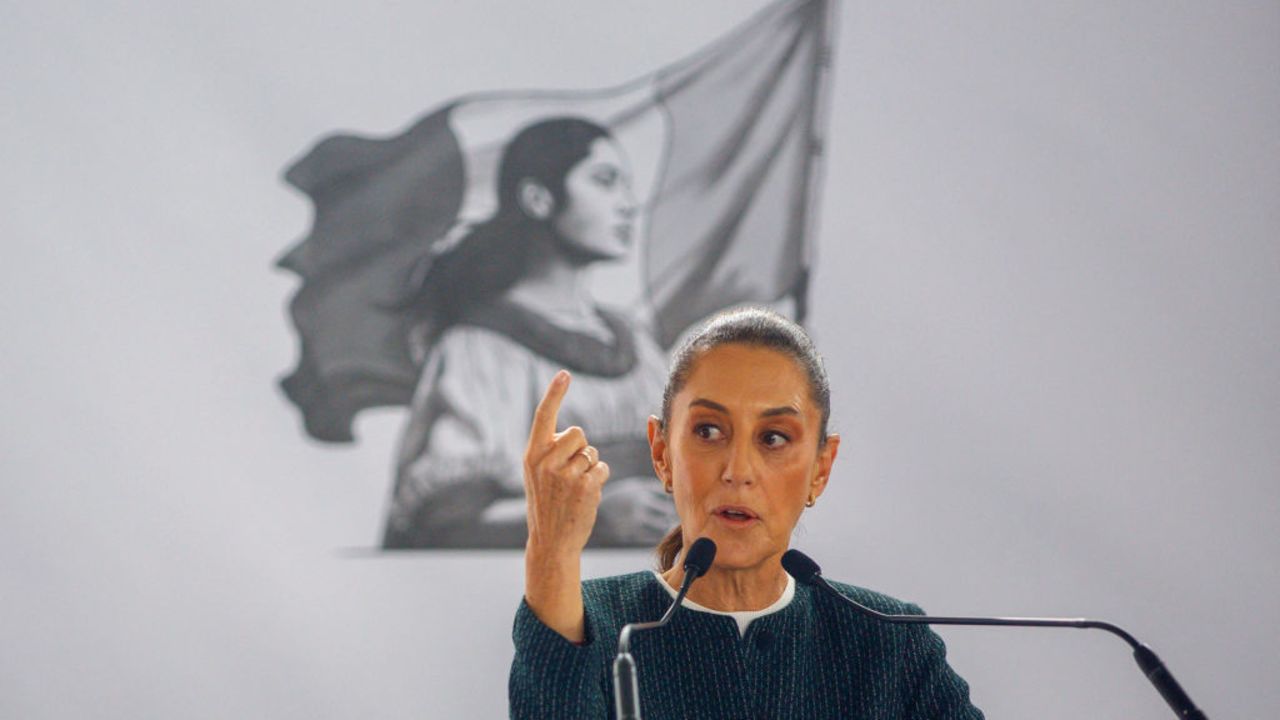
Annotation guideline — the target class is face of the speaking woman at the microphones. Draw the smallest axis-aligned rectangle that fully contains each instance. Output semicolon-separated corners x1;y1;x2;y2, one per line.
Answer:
649;345;840;569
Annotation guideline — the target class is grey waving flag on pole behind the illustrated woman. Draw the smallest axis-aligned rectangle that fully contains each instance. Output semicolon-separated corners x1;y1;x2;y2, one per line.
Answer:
279;0;831;442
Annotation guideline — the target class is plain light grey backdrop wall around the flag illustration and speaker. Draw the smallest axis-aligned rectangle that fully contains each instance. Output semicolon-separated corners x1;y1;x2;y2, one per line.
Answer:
0;0;1280;719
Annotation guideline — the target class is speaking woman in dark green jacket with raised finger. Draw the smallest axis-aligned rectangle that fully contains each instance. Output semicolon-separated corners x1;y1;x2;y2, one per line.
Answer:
509;310;982;720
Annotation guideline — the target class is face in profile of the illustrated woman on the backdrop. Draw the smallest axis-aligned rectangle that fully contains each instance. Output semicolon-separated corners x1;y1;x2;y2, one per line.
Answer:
553;137;636;260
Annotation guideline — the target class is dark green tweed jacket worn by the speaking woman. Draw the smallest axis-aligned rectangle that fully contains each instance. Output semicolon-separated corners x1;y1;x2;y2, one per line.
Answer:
508;573;983;720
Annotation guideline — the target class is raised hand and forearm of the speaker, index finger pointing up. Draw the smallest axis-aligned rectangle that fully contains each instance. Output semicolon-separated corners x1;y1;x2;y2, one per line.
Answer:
525;370;609;642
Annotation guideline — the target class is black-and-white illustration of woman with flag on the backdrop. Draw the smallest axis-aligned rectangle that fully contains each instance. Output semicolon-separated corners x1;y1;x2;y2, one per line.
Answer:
280;1;833;548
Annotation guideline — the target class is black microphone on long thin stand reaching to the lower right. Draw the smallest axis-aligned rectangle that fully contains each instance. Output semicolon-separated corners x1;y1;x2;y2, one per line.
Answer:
782;550;1208;720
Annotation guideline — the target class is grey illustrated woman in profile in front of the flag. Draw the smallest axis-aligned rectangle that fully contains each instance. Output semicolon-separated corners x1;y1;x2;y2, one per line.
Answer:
384;118;675;548
